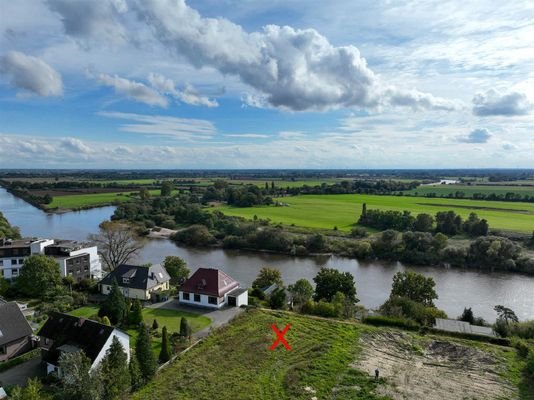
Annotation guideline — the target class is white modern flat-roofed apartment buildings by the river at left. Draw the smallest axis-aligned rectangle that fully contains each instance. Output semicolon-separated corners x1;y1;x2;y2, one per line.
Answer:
0;238;102;281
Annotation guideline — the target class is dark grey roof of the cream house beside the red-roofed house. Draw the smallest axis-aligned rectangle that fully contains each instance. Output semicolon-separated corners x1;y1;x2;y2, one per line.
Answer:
100;264;171;290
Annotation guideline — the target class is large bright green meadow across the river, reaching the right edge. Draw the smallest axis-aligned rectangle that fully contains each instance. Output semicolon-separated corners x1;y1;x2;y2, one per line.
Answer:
215;194;534;232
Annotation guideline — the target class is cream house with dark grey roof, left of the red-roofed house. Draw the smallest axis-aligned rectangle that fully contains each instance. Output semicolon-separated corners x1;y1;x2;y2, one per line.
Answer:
98;264;171;300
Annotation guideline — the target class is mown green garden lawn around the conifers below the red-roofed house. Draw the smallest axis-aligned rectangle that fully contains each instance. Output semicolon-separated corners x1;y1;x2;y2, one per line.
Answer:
69;306;211;355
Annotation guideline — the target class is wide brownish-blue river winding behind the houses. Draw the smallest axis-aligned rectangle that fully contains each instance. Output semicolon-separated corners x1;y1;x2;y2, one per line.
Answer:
0;188;534;321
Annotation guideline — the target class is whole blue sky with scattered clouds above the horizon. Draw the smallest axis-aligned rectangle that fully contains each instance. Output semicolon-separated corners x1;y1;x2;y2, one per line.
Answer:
0;0;534;169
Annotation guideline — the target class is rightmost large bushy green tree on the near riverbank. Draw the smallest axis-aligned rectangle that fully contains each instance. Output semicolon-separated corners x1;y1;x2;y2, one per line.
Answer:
390;271;438;306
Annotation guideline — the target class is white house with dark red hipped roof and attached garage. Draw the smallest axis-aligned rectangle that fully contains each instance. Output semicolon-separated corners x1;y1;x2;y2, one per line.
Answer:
178;268;248;308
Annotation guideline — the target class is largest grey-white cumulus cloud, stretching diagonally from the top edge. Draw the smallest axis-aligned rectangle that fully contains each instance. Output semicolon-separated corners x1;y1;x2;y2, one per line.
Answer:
134;0;455;111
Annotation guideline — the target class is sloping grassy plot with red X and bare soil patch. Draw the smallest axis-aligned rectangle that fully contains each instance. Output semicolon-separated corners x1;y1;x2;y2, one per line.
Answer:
132;310;521;400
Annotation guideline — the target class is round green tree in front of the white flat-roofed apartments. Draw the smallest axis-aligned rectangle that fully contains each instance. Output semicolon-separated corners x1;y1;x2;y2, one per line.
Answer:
16;254;61;298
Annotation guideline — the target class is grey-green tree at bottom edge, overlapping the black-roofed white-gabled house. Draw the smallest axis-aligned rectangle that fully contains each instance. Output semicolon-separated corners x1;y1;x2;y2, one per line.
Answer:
59;351;104;400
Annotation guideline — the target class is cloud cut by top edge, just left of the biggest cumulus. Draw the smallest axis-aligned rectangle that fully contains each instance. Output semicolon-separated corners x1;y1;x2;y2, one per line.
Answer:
48;0;128;43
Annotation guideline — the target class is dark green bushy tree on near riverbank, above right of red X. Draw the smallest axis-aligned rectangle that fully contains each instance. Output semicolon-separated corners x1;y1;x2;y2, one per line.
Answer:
313;268;359;303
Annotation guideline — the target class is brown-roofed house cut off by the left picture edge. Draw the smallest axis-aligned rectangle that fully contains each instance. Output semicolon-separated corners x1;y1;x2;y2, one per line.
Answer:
0;302;35;361
